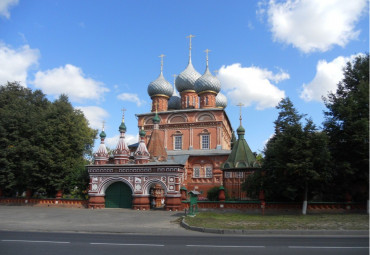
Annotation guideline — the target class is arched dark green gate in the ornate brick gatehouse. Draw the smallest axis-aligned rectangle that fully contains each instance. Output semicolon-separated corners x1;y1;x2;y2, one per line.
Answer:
105;182;132;208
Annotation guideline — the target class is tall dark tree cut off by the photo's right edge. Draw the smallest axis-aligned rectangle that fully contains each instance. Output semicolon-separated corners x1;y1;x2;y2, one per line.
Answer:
324;54;369;200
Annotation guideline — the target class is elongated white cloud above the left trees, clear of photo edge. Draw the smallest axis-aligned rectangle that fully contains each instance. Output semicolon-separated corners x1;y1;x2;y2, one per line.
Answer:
33;64;109;102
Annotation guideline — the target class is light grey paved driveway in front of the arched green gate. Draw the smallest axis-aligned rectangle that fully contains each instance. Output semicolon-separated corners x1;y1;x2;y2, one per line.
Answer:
0;205;196;235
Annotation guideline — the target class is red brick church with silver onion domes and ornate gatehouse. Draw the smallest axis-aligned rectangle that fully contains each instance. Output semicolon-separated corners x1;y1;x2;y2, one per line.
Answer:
87;36;256;210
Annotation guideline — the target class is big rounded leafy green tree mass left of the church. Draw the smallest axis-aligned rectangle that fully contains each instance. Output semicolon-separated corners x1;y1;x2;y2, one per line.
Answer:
0;82;96;196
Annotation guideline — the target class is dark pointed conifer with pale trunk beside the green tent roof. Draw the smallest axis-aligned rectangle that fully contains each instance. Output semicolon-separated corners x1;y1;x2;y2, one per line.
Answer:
258;98;330;211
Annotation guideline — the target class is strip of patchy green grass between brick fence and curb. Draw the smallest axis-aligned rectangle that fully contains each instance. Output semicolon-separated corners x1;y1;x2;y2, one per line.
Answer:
185;212;369;230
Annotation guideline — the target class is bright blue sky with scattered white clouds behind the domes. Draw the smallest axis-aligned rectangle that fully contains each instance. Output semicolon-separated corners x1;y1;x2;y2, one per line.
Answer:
0;0;369;153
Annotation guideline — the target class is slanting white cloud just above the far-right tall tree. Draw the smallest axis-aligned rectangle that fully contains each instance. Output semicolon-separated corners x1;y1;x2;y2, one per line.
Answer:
300;54;361;102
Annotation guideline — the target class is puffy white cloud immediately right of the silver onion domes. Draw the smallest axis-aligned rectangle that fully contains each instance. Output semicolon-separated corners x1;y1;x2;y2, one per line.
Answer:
217;63;289;110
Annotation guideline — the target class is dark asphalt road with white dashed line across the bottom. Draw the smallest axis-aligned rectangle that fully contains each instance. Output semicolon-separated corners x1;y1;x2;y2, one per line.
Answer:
0;231;369;255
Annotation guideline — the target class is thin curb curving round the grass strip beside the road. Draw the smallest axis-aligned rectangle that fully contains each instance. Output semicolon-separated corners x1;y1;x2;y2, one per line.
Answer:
180;218;369;237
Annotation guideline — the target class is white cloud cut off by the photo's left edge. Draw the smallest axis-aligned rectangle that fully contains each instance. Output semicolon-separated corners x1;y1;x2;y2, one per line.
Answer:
0;42;40;86
